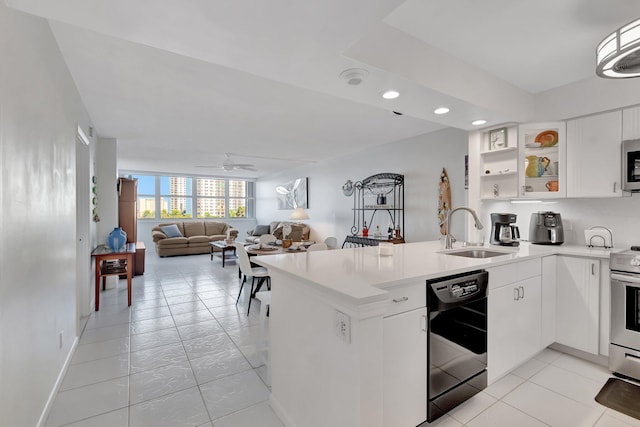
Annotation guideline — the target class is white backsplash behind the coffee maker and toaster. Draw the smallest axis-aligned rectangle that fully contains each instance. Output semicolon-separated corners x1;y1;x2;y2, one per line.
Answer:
481;197;640;250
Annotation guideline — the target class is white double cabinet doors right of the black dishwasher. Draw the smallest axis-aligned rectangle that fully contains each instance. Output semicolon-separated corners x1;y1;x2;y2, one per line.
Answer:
487;276;542;384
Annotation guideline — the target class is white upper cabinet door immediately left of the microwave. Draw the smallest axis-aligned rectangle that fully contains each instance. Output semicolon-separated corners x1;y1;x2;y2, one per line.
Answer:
567;111;622;197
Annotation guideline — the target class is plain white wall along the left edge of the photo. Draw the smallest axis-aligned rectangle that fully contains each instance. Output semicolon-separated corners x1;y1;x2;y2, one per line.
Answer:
0;2;94;426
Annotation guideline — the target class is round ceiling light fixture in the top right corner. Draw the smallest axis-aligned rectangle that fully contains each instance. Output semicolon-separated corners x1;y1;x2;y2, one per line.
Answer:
596;19;640;79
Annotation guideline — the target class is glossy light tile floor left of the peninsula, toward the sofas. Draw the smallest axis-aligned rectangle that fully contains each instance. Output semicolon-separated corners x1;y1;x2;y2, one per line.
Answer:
46;252;283;427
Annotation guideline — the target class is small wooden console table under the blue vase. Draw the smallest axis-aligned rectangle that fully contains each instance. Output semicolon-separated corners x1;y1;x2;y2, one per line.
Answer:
91;243;136;311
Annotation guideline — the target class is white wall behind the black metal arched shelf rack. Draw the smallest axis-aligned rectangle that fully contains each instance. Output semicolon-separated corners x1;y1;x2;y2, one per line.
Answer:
256;128;468;244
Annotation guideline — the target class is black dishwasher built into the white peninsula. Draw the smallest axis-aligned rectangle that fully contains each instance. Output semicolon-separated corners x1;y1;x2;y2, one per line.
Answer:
427;270;489;422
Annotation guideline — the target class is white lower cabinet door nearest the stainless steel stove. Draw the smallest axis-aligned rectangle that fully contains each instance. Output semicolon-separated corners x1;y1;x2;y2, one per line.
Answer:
556;255;600;355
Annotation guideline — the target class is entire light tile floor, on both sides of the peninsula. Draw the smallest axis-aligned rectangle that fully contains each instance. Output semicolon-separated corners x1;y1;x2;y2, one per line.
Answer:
46;252;640;427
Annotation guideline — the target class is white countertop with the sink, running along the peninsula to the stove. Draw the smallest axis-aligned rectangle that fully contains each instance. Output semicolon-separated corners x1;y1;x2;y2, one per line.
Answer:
252;241;620;304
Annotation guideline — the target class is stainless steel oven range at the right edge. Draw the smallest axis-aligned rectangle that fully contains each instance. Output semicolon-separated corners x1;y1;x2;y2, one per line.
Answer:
609;246;640;379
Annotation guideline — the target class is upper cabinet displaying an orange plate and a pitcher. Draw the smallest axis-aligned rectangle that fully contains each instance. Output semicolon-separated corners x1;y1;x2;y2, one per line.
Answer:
518;122;567;198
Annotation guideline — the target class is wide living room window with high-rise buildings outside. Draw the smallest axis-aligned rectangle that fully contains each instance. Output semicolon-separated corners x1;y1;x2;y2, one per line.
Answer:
133;175;254;219
